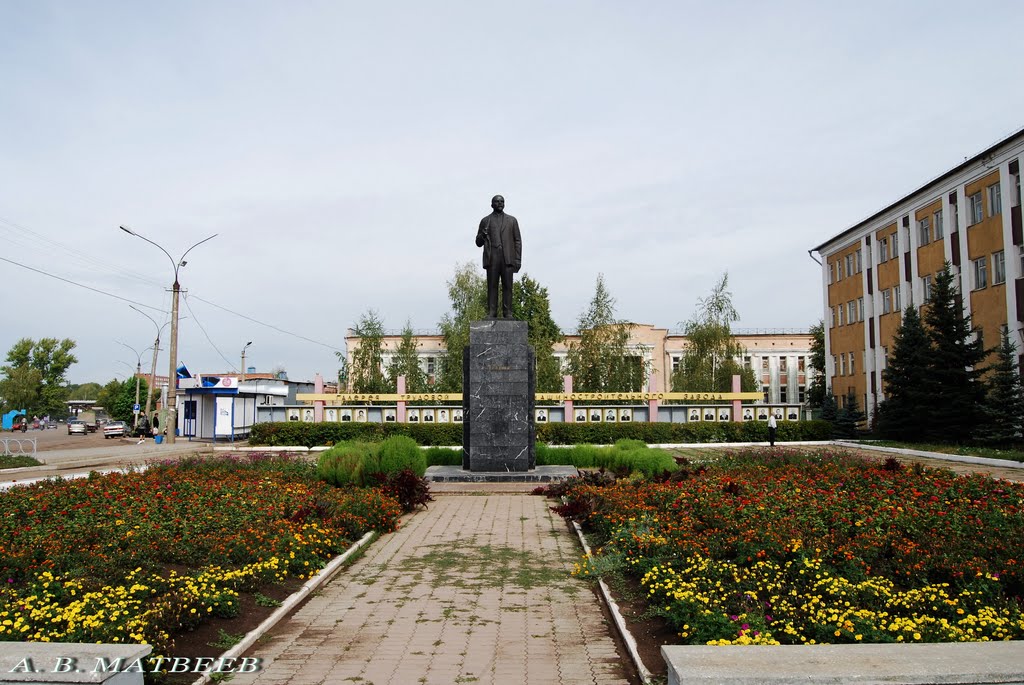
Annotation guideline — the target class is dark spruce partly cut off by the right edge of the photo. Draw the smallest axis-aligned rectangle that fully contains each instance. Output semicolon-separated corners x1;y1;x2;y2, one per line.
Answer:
977;331;1024;444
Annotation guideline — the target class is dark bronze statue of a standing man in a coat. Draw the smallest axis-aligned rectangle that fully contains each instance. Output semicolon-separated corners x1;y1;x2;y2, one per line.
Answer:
476;195;522;318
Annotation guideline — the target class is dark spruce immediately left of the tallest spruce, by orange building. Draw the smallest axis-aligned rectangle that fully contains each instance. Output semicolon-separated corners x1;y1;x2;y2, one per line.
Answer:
874;304;934;440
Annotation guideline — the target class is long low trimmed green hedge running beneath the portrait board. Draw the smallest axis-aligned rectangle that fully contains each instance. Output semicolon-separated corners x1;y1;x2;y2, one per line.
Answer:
249;421;831;447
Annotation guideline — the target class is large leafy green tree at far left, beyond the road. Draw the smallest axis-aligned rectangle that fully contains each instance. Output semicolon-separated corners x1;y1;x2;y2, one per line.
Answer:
0;338;78;416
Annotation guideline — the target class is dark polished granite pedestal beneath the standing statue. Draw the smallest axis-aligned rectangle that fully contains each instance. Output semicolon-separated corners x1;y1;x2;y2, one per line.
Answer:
462;318;536;473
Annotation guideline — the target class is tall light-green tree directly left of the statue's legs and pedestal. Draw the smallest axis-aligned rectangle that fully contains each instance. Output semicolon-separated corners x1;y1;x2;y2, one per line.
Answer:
434;262;487;392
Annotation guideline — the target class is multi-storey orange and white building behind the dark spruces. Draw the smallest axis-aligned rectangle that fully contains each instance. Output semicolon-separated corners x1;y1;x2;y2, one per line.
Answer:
811;130;1024;413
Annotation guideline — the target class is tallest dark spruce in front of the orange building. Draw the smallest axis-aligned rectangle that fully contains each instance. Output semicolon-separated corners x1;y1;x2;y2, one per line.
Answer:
923;262;986;443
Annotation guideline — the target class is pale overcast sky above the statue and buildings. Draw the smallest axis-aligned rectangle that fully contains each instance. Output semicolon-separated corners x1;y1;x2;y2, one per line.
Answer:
0;0;1024;383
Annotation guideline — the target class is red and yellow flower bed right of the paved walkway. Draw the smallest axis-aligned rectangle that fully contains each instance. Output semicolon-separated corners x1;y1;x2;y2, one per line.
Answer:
557;449;1024;644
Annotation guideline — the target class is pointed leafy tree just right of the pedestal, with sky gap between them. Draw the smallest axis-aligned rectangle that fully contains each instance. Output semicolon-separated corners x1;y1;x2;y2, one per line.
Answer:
568;273;647;392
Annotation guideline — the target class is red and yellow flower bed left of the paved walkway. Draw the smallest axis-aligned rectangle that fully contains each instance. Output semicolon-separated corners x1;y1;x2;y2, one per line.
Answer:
0;456;400;653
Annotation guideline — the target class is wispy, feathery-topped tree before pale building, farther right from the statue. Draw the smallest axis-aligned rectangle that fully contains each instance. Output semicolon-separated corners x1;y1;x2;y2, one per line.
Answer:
672;273;757;392
